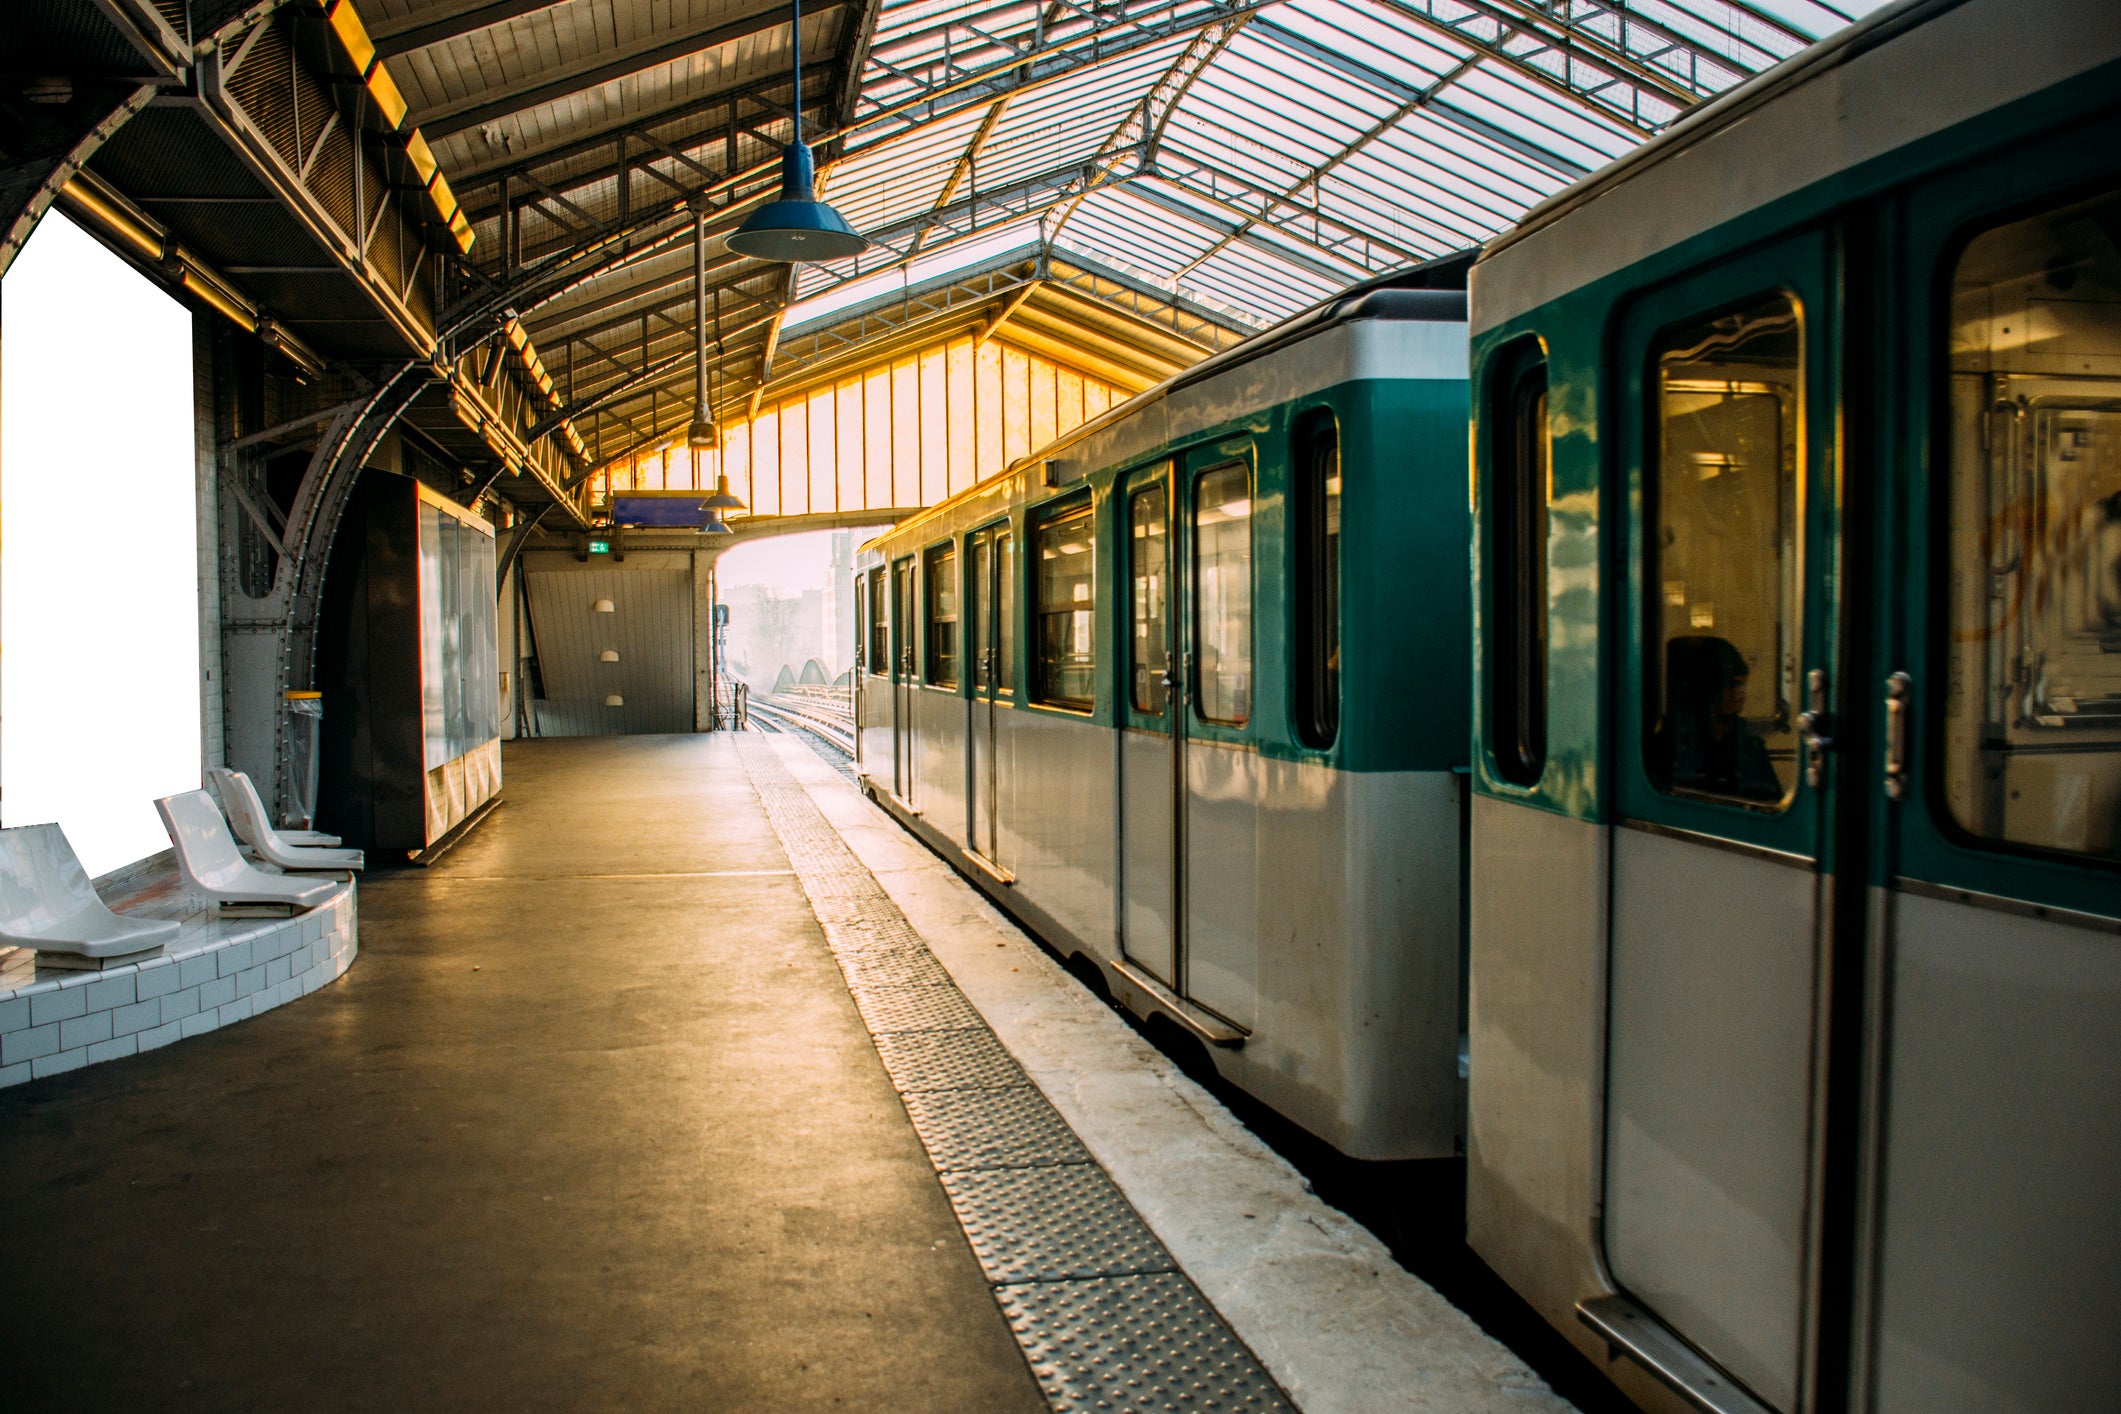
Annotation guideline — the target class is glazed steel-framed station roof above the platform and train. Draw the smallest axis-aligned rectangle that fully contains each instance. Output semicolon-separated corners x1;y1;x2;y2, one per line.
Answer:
12;0;1877;522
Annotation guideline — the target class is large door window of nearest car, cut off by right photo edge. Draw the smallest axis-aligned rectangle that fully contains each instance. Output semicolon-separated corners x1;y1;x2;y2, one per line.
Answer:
1941;191;2121;861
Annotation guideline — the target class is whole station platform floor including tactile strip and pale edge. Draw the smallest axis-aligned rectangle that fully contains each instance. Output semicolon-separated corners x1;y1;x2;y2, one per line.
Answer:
0;733;1567;1414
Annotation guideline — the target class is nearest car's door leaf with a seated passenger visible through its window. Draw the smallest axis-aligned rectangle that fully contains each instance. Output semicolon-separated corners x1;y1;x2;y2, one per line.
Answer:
1603;235;1860;1414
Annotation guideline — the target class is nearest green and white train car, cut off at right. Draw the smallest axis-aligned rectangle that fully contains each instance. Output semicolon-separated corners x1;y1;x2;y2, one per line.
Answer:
1468;0;2121;1414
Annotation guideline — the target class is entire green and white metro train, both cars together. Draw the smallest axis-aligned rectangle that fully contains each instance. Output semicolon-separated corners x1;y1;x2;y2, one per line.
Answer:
857;0;2121;1414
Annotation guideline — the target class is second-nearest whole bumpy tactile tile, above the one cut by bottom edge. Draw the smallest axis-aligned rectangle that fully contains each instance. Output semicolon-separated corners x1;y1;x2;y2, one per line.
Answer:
942;1164;1177;1285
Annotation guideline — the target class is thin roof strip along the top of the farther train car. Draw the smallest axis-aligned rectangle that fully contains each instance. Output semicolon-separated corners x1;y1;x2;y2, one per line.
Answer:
861;250;1476;549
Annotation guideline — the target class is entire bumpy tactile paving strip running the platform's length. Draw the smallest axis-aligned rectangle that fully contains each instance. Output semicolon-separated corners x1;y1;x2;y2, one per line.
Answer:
736;736;1294;1414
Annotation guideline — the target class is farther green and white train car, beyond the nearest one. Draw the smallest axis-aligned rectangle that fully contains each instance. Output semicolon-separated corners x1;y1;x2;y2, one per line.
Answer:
857;257;1470;1157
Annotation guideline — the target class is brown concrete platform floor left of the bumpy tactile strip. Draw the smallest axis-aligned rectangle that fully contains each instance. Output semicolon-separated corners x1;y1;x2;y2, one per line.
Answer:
0;738;1046;1412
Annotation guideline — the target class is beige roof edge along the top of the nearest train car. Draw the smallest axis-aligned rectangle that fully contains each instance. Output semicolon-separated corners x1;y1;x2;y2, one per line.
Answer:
1472;0;2121;333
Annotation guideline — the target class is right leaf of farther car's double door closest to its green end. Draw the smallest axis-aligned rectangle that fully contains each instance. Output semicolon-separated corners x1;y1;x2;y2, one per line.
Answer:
1173;441;1264;1028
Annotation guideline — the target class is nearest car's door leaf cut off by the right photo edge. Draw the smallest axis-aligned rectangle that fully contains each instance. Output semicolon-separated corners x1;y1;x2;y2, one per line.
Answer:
1856;163;2121;1414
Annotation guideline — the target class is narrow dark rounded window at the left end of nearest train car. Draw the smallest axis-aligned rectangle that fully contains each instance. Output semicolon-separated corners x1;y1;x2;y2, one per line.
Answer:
1487;343;1553;786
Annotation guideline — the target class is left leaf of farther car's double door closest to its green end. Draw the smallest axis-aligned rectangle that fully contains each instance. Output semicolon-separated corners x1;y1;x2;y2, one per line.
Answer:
1118;462;1179;988
